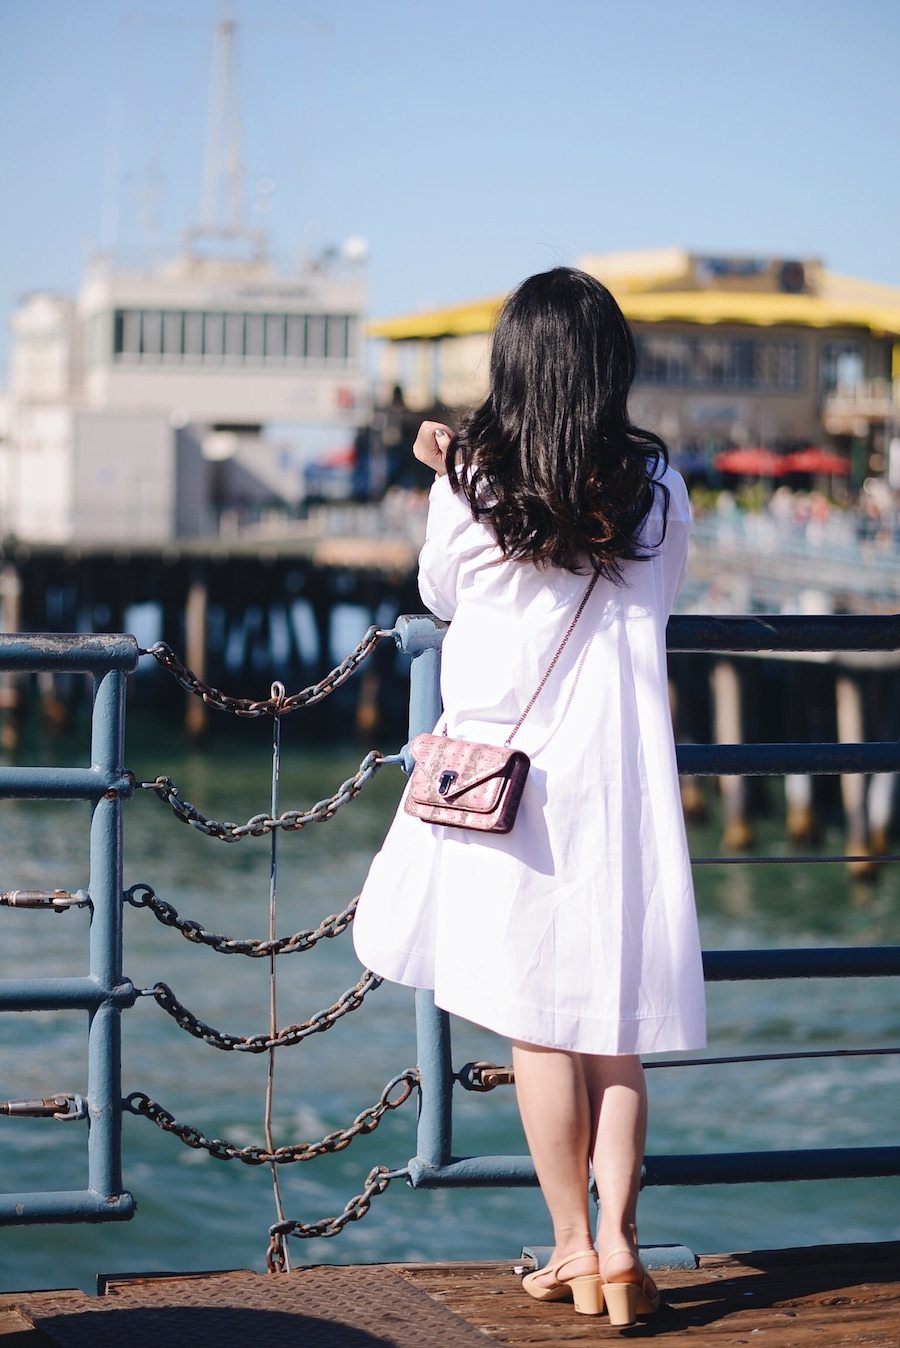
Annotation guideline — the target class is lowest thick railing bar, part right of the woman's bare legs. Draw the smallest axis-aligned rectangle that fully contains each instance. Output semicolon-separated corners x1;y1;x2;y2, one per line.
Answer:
643;1147;900;1186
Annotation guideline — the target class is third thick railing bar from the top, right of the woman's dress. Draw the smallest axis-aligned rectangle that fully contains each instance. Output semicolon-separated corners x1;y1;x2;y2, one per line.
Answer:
703;945;900;983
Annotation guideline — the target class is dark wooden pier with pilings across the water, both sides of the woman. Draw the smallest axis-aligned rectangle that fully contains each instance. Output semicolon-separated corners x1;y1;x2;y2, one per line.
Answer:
0;520;900;846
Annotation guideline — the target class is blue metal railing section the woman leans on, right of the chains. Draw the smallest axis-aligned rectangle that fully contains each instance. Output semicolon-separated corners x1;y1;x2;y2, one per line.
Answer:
396;615;900;1188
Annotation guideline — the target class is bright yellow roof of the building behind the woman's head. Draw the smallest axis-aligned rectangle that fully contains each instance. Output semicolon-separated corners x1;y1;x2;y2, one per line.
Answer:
369;264;900;341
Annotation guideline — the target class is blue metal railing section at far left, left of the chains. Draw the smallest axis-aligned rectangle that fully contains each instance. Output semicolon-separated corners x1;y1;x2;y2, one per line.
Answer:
0;635;137;1224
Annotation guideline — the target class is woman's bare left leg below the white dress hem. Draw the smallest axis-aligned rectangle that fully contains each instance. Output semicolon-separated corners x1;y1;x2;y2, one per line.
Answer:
512;1042;597;1278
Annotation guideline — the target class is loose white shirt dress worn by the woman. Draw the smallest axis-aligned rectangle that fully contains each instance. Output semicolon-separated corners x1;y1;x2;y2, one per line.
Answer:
353;466;706;1054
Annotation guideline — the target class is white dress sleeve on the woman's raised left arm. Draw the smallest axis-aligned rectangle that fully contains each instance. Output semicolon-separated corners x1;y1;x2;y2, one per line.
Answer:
419;477;496;619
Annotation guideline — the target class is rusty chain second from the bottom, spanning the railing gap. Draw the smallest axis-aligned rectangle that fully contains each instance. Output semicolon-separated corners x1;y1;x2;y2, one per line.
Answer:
123;1068;419;1166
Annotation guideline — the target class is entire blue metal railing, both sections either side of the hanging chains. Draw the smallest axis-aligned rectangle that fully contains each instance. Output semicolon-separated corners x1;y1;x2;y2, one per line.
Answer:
0;616;900;1224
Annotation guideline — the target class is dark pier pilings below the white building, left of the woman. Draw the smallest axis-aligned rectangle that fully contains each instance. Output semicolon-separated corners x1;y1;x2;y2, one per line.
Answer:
0;523;422;739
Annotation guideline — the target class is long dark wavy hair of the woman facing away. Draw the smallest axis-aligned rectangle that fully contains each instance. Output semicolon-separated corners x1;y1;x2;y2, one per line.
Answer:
447;267;668;581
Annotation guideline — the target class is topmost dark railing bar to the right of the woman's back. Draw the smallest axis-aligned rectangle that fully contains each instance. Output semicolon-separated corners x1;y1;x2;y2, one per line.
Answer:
666;613;900;654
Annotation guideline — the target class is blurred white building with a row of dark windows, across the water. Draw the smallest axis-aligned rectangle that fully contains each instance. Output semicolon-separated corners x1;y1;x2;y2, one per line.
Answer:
0;253;368;542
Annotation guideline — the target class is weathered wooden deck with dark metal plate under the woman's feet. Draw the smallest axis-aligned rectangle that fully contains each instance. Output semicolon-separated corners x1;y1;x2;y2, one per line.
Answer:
0;1242;900;1348
